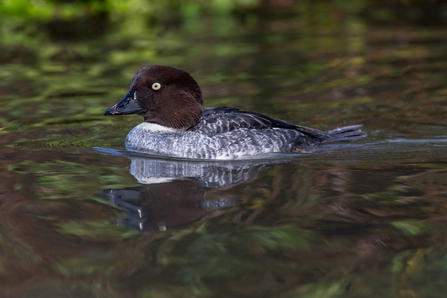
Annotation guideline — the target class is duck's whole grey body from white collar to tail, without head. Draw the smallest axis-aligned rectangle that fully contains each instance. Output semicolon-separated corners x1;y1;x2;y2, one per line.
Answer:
125;108;366;159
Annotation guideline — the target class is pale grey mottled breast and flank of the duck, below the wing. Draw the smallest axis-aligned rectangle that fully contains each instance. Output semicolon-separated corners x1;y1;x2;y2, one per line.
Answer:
125;123;312;159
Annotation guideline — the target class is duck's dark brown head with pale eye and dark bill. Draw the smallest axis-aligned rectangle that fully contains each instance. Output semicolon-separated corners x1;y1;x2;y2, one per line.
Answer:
104;65;203;129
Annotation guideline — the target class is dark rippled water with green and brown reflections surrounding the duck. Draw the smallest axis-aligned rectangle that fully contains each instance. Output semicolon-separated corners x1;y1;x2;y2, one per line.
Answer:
0;0;447;297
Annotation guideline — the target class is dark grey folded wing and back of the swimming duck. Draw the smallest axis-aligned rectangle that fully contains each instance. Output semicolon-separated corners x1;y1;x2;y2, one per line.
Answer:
189;107;328;139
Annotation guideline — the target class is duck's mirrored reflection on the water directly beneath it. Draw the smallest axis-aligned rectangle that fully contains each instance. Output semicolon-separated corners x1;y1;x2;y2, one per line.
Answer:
103;157;271;232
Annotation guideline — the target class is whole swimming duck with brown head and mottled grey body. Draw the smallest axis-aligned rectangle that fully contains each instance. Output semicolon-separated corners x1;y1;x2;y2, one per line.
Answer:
104;65;366;159
